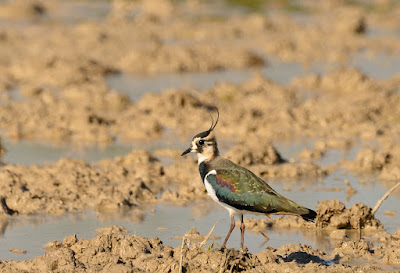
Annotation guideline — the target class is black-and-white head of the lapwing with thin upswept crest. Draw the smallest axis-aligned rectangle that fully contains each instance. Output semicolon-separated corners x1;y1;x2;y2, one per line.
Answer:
182;108;219;164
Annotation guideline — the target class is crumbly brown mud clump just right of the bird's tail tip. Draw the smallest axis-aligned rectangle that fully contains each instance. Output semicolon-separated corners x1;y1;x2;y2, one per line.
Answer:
316;200;382;229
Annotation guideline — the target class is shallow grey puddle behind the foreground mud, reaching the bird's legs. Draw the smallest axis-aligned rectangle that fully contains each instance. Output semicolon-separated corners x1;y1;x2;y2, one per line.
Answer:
0;200;332;260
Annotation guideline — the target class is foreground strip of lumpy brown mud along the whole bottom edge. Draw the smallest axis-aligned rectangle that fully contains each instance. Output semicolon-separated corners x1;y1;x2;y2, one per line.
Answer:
0;223;400;272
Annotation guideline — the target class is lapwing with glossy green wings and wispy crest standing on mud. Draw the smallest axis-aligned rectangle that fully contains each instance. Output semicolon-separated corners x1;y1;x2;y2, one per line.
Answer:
181;107;317;251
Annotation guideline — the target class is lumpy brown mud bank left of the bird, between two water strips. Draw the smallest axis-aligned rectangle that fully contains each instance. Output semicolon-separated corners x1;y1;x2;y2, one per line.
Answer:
0;151;166;215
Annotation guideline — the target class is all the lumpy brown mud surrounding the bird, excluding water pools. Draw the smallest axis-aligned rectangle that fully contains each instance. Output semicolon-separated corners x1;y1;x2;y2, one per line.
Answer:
0;0;400;272
